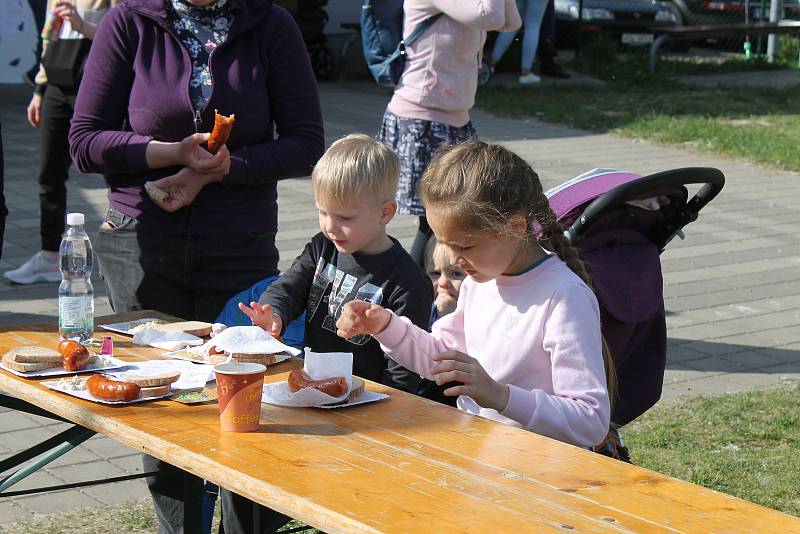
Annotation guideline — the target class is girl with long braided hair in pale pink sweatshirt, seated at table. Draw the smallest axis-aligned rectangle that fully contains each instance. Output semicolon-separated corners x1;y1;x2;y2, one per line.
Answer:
336;141;614;448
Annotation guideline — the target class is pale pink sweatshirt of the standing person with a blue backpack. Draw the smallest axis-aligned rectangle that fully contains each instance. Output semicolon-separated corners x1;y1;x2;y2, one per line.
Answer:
389;0;522;126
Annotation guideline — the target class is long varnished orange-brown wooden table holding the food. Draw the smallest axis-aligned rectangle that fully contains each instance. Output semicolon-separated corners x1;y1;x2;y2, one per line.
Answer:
0;312;800;533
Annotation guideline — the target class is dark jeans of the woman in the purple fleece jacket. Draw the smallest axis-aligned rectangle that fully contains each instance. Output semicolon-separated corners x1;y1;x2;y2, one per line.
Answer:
94;208;285;534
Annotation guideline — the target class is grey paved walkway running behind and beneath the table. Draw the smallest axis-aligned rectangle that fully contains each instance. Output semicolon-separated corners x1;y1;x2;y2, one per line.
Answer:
0;83;800;522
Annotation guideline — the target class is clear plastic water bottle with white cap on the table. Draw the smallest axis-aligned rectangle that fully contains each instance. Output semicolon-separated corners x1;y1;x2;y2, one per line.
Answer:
58;213;94;342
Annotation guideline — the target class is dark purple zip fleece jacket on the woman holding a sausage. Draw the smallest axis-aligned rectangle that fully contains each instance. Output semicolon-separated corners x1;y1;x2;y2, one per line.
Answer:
69;0;325;235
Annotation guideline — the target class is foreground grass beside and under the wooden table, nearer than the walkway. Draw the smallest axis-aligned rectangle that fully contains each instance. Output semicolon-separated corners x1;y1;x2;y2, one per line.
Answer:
0;384;800;534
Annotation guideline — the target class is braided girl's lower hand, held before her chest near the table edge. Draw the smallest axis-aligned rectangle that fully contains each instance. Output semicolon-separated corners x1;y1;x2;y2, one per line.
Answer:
431;350;509;412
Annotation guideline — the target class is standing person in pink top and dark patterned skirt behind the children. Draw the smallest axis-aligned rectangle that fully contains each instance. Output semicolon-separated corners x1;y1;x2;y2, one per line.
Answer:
378;0;522;265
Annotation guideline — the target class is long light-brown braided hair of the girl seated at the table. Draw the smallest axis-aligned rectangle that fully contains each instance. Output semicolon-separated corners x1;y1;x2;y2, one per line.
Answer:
419;140;617;401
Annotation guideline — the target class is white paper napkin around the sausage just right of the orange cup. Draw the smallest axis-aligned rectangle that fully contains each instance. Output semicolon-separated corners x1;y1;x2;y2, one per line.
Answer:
261;347;353;407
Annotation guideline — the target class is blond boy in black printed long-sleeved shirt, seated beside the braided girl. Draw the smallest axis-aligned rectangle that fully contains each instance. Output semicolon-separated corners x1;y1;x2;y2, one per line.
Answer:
239;134;433;393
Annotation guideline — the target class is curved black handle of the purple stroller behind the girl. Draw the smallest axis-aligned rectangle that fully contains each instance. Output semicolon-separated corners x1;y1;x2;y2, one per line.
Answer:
564;167;725;250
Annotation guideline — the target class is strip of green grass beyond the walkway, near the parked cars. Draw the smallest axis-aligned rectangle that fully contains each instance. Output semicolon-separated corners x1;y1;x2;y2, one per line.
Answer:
477;40;800;171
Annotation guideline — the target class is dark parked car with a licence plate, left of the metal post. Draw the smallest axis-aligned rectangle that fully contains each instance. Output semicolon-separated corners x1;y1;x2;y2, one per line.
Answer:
555;0;680;46
